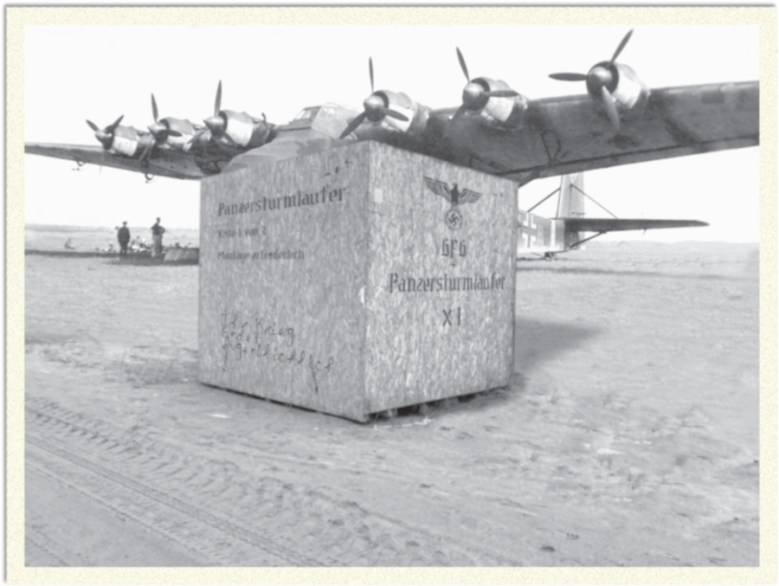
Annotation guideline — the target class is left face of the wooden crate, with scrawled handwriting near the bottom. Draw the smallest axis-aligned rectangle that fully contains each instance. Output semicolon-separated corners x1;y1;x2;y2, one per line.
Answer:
199;145;368;420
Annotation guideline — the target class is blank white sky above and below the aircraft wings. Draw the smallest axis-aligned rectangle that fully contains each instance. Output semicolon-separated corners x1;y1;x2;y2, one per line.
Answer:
24;25;759;242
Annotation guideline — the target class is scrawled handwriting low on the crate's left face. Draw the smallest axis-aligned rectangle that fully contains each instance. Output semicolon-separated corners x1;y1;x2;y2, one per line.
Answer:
221;311;335;393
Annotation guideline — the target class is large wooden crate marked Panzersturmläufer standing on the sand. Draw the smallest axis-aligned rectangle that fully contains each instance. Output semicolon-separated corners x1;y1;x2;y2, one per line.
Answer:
199;142;517;421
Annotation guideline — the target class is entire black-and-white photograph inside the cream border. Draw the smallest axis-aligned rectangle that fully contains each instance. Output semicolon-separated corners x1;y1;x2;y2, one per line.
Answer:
8;8;776;584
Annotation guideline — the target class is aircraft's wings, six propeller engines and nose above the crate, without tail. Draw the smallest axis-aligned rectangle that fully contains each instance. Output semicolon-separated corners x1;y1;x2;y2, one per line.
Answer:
25;31;759;188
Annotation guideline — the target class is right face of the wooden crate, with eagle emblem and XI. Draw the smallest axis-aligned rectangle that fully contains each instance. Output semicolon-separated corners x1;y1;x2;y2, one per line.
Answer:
366;144;517;412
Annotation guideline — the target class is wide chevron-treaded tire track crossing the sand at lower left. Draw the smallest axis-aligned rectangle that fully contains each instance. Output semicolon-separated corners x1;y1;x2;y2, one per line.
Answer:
27;398;520;566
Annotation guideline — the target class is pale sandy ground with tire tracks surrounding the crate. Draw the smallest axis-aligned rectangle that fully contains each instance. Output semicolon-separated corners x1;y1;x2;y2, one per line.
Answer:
25;234;759;566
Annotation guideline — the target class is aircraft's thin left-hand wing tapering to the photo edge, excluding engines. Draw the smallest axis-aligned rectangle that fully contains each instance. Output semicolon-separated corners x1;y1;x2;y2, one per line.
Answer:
24;143;212;179
